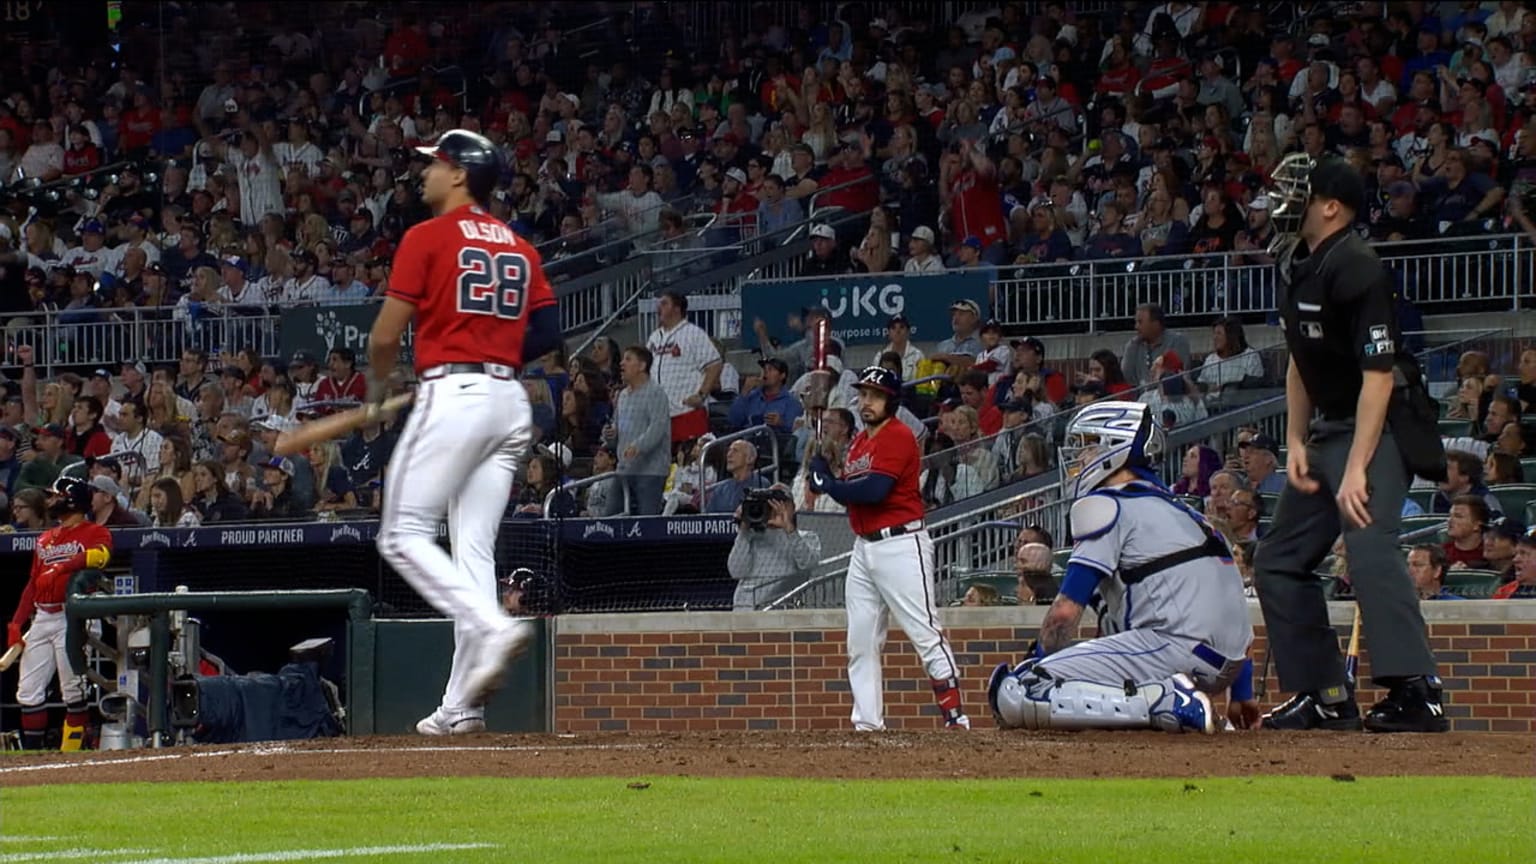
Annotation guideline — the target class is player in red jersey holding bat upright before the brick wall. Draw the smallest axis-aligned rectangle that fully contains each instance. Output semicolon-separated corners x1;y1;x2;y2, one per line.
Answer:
808;366;971;732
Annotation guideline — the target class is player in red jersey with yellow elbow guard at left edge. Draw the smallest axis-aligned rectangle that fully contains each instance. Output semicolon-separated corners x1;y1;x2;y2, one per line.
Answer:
6;477;112;750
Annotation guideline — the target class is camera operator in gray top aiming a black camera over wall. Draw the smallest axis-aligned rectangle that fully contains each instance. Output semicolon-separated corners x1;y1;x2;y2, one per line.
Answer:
725;484;822;612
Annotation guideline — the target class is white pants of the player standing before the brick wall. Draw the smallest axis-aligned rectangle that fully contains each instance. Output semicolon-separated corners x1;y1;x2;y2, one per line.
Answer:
843;530;960;732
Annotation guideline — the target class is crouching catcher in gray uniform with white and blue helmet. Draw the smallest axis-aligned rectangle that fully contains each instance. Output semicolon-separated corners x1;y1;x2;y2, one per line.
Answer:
988;401;1258;735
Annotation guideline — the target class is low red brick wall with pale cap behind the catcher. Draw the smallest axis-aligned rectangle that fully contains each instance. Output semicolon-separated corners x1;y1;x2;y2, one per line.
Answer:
553;601;1536;732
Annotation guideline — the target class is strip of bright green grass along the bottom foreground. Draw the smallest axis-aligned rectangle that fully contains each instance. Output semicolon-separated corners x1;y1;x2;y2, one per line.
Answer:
0;778;1536;864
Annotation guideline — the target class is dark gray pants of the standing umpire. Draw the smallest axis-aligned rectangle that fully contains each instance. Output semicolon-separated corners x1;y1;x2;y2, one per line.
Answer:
1253;421;1435;693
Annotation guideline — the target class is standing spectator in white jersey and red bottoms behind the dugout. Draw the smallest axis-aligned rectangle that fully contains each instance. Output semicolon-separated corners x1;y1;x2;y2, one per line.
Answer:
645;291;722;445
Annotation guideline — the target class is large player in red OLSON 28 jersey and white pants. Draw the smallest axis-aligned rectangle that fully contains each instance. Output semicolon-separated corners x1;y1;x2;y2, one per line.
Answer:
369;129;561;735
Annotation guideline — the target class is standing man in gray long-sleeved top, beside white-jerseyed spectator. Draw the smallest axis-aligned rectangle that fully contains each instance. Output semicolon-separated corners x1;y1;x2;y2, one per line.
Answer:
604;346;670;517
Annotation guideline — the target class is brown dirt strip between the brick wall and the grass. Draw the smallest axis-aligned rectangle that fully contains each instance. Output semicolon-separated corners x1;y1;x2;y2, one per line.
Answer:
0;730;1536;784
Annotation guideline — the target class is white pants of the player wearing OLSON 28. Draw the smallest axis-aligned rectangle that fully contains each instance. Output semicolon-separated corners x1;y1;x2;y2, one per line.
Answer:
378;371;533;716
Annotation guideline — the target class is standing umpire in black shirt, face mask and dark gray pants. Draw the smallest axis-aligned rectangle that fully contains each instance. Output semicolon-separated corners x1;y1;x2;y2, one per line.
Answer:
1253;158;1450;732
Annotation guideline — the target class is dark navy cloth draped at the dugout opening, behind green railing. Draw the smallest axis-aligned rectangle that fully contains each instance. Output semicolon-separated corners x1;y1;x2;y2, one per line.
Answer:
197;663;341;744
